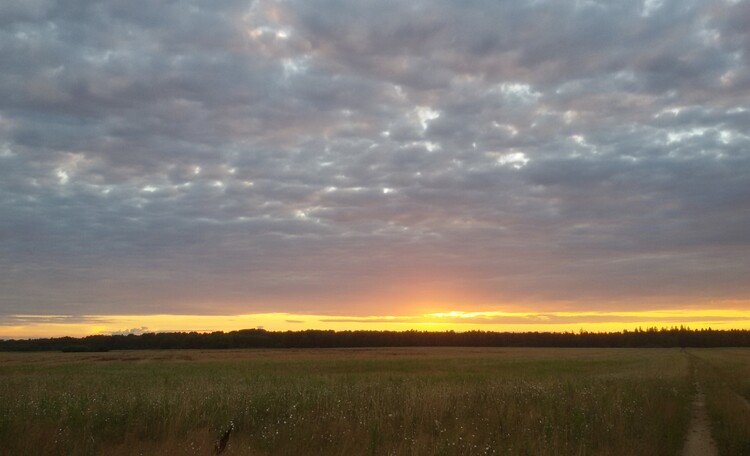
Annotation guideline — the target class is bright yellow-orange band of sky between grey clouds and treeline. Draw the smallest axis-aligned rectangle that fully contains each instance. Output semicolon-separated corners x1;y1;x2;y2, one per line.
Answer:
0;309;750;339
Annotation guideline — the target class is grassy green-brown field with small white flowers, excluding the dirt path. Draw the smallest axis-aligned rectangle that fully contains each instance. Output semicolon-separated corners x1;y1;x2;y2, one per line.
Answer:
0;348;750;455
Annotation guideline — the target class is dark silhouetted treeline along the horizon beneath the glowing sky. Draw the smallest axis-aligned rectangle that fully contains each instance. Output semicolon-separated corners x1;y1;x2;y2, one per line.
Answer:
0;327;750;352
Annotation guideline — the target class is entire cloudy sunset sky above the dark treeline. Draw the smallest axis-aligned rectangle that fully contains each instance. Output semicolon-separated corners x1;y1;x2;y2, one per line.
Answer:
0;0;750;337
